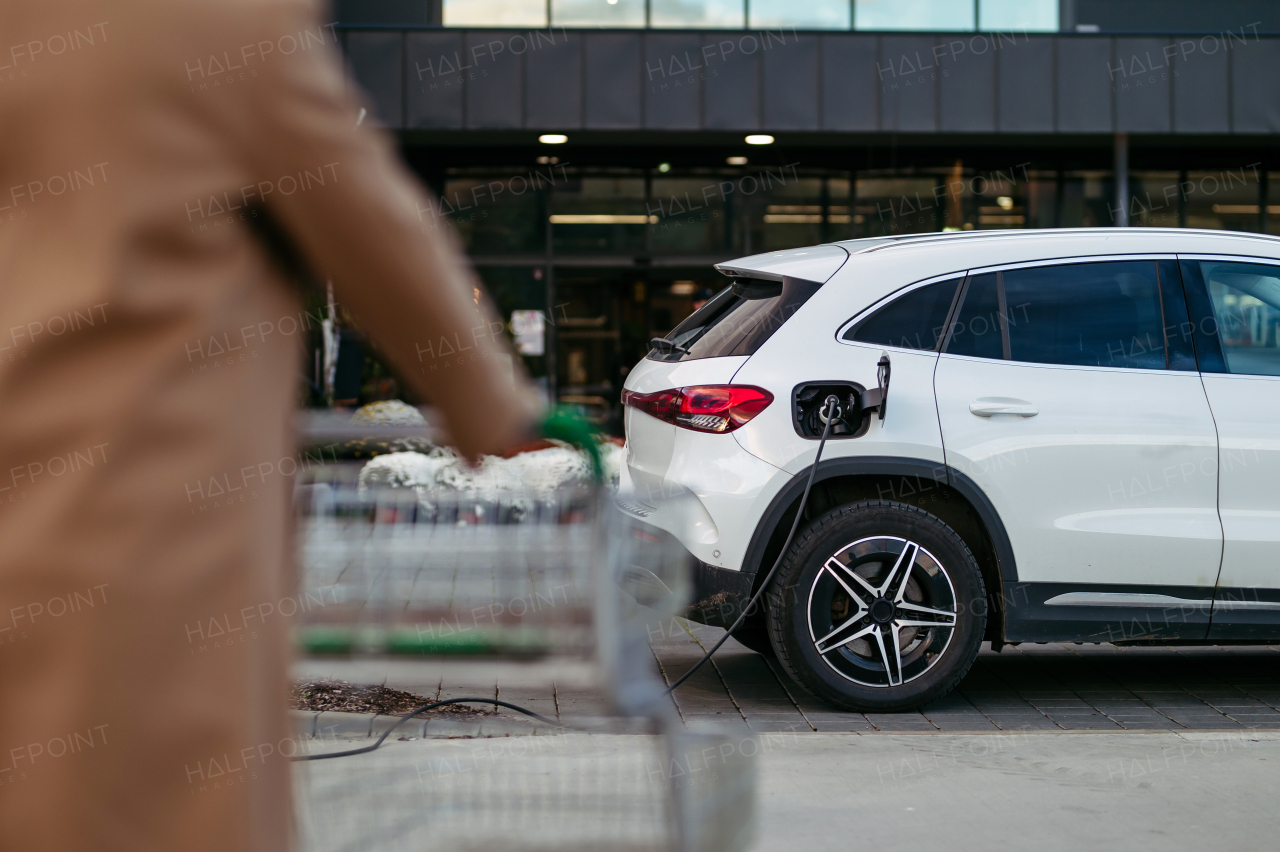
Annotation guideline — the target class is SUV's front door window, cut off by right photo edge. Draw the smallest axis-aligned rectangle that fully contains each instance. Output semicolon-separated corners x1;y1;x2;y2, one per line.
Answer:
1193;261;1280;376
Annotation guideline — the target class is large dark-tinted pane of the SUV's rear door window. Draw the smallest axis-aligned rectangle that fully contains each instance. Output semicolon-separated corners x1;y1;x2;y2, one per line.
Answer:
1000;261;1165;370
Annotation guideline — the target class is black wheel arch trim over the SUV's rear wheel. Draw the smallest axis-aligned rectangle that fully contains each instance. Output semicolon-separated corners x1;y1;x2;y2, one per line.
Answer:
742;455;1018;643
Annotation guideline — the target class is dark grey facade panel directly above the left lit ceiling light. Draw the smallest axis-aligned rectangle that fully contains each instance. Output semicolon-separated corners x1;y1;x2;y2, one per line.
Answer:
516;29;582;130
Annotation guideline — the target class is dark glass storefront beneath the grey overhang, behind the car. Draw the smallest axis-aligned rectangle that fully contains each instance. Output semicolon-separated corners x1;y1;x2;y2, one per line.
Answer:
417;156;1280;430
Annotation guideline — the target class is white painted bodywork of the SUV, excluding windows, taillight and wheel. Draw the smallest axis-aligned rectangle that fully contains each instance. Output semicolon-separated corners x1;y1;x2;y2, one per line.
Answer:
622;229;1280;641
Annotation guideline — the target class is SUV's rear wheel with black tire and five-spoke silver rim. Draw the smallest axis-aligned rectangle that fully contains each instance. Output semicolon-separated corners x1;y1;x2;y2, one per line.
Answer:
767;500;987;713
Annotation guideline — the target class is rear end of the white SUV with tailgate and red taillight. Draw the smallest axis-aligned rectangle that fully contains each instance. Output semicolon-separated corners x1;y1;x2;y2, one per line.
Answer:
618;246;849;623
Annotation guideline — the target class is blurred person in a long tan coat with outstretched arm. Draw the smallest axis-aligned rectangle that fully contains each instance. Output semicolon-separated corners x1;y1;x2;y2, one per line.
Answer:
0;0;539;852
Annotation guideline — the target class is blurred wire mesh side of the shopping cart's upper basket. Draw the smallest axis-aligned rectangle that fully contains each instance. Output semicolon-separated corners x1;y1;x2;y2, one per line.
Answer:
298;476;602;658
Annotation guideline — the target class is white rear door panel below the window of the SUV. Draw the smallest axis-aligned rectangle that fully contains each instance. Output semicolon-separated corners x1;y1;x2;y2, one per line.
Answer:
934;354;1222;588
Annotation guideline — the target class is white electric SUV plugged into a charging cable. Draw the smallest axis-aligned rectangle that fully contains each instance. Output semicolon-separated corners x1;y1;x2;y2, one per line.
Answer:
618;229;1280;710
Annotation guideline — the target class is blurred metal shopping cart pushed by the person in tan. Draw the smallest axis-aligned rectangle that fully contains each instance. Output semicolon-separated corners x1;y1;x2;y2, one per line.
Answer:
288;409;755;852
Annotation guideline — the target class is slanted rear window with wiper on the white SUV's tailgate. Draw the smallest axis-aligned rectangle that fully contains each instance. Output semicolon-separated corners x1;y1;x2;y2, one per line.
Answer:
649;278;822;361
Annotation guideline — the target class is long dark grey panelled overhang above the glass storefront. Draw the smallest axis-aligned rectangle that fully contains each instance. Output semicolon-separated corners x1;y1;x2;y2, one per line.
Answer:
342;28;1280;134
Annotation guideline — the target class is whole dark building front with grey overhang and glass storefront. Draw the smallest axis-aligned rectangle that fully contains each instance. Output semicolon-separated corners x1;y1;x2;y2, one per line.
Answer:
327;9;1280;430
